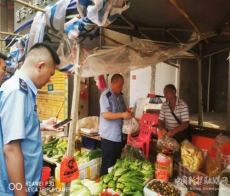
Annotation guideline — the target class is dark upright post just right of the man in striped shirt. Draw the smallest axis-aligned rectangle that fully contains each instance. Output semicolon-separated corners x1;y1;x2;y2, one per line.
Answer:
198;42;203;126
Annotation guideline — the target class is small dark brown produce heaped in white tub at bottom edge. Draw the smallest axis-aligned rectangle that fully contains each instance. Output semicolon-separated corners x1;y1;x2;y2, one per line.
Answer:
148;180;181;196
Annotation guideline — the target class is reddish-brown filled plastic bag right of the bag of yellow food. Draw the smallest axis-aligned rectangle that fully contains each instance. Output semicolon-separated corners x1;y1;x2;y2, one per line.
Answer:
202;142;221;177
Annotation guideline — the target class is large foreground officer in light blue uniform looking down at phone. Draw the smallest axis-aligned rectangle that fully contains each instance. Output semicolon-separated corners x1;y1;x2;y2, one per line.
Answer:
0;43;60;196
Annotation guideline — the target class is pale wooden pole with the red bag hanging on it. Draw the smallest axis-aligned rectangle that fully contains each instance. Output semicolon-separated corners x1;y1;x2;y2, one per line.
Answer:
62;44;80;196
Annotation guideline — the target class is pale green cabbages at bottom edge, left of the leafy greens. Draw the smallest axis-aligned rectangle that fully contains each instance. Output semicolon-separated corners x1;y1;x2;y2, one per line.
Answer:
67;179;103;196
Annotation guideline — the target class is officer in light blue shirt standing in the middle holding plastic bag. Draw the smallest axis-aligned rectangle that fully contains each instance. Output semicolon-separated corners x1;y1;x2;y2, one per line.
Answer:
99;74;132;176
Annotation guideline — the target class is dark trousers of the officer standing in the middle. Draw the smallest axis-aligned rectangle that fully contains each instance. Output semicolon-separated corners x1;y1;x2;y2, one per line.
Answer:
101;139;123;176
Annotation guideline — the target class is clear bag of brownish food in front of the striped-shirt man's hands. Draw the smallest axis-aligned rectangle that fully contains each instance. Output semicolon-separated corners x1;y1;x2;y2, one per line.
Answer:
157;136;180;151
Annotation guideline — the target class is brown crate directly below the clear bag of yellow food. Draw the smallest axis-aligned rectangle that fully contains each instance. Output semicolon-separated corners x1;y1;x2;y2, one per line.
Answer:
178;163;219;196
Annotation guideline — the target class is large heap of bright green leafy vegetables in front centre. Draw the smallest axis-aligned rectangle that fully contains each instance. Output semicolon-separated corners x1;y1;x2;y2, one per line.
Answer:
100;157;154;196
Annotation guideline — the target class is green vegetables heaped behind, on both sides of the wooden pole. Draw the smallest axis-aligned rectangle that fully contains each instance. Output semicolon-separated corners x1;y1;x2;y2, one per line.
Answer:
43;138;101;165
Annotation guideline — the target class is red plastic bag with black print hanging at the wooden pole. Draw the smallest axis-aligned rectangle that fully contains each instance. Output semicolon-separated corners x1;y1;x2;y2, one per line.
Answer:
60;154;79;183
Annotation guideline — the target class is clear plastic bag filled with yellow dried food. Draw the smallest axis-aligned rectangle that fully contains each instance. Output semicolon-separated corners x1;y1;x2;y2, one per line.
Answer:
181;140;204;172
